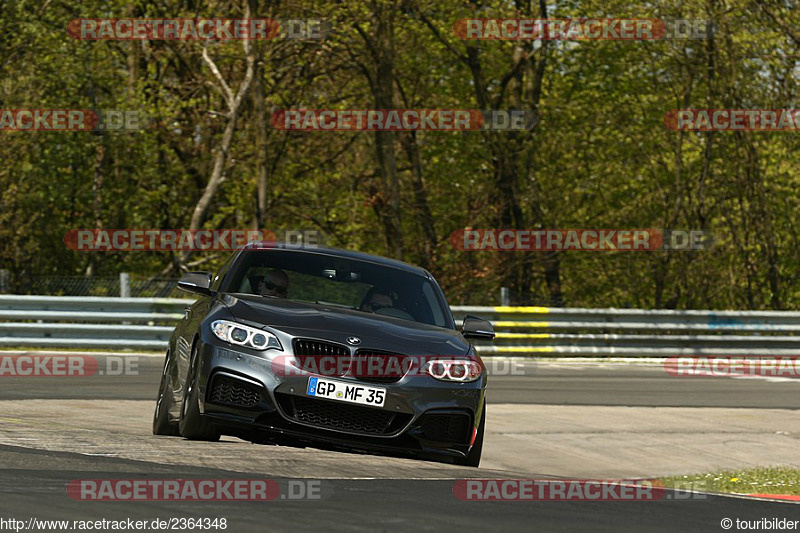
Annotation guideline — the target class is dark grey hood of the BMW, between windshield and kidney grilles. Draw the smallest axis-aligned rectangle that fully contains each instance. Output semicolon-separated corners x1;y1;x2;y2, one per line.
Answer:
221;294;469;355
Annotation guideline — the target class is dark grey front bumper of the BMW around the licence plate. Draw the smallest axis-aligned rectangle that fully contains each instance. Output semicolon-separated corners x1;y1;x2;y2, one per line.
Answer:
194;341;486;457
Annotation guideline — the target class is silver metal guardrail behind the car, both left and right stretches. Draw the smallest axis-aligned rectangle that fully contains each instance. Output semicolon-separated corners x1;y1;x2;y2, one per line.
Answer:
0;295;800;357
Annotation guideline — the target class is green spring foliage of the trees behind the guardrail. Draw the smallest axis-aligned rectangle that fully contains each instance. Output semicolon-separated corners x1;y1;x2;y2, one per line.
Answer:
0;0;800;309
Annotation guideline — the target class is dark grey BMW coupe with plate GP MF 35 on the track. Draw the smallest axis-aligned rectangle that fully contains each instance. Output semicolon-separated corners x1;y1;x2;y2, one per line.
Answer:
153;243;494;466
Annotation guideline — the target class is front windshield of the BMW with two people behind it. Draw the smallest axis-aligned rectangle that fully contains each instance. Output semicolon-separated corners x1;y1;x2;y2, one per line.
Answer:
225;250;447;327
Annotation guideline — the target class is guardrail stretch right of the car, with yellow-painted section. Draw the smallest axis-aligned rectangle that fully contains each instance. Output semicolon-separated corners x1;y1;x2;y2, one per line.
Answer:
453;306;800;357
